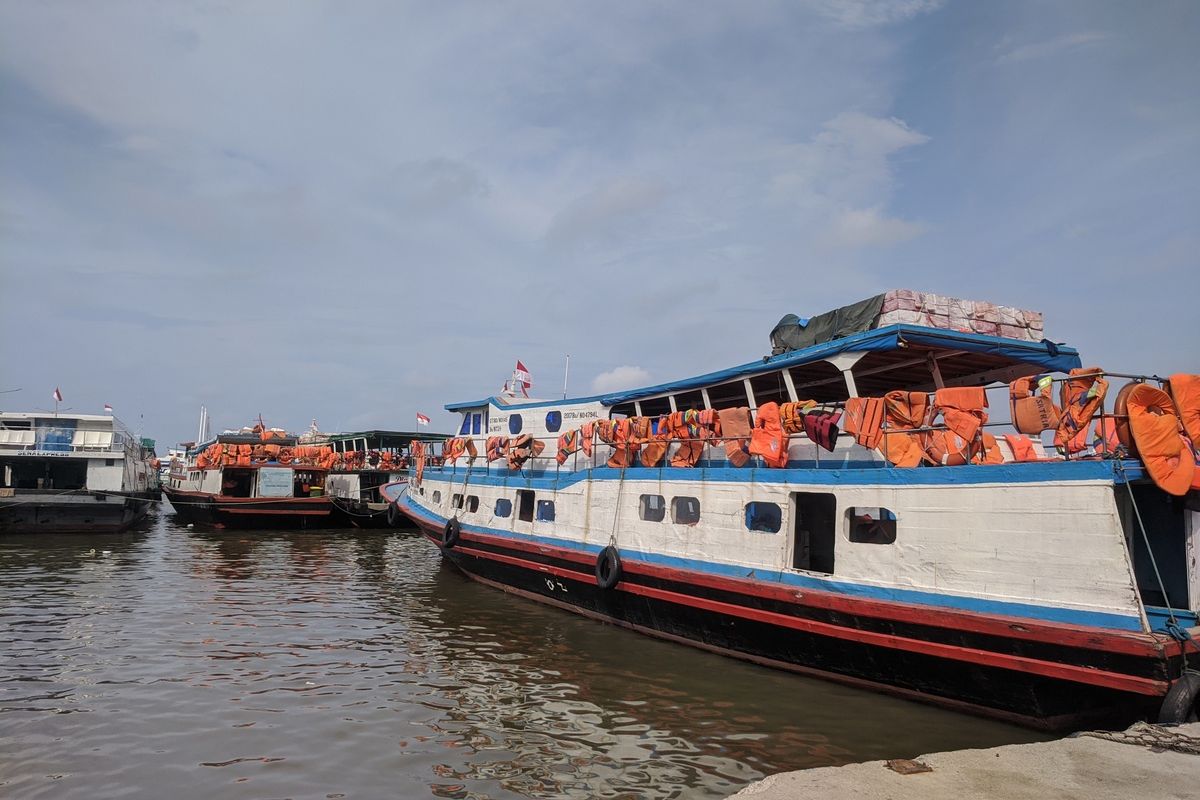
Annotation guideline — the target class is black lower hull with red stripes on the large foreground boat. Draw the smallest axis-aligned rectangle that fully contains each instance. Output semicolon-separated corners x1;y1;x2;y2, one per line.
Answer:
400;500;1178;729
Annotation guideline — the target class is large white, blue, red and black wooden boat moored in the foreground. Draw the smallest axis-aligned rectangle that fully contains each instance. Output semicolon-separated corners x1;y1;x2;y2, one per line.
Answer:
398;290;1200;728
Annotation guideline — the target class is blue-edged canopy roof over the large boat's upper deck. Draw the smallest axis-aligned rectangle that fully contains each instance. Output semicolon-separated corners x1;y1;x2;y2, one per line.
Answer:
445;324;1082;411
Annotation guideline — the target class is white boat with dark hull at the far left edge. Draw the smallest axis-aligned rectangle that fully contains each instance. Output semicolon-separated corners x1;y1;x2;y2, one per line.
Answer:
0;411;158;534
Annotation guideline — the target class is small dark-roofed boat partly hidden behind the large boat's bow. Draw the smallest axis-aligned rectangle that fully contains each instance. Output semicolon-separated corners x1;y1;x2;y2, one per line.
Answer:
325;431;446;528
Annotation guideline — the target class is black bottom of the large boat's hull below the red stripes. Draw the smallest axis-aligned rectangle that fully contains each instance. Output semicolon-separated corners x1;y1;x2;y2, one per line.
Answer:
427;530;1164;730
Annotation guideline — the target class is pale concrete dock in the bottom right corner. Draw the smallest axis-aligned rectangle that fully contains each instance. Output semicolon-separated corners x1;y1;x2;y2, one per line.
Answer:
732;723;1200;800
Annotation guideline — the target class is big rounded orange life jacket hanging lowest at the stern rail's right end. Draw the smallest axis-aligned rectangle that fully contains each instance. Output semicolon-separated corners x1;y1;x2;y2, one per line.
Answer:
1127;384;1196;497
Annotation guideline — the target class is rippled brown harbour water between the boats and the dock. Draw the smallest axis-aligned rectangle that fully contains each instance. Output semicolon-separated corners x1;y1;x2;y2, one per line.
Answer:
0;516;1037;800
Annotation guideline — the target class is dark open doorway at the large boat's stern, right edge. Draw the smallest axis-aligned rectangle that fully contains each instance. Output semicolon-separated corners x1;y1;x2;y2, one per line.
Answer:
1116;482;1200;625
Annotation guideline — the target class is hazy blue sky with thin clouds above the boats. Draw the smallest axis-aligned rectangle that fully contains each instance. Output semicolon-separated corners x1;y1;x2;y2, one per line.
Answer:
0;0;1200;443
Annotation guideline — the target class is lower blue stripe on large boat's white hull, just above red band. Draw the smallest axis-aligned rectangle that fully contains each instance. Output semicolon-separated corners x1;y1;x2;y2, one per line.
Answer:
401;496;1142;631
